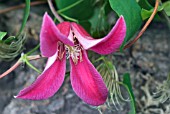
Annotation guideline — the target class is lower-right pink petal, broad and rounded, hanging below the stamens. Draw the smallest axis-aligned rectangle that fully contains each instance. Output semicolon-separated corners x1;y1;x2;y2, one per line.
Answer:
70;51;108;106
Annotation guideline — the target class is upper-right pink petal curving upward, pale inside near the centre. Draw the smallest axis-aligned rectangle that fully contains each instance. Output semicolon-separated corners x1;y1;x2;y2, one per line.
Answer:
72;16;126;54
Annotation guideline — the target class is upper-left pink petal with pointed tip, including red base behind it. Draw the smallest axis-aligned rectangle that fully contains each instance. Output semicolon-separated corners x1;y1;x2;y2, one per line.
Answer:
40;13;73;57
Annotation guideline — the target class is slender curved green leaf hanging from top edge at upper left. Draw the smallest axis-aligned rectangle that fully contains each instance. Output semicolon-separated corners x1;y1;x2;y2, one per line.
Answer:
17;0;30;36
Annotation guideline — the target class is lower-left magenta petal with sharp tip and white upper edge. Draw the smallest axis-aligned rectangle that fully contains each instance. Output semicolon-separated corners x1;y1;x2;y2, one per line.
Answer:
16;55;66;100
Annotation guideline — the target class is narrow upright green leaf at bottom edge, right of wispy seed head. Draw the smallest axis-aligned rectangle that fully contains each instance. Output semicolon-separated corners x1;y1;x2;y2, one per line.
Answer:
123;73;136;114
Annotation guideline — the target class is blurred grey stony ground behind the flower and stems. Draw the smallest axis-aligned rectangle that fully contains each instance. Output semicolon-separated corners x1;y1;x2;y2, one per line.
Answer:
0;1;170;114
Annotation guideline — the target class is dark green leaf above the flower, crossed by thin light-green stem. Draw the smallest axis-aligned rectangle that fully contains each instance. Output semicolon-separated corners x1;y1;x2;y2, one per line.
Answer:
55;0;93;20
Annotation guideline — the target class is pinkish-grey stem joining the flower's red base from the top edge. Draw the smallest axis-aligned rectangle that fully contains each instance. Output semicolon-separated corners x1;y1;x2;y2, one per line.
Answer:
47;0;64;23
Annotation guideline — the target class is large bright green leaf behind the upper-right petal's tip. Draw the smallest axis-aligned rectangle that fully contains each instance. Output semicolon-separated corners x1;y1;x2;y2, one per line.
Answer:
109;0;142;49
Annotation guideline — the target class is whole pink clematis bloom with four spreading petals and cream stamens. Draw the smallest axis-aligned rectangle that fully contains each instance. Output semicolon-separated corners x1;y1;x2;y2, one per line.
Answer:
16;13;126;106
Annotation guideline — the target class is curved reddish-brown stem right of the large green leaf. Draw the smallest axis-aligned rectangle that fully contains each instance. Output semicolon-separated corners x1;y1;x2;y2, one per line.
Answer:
123;0;159;49
